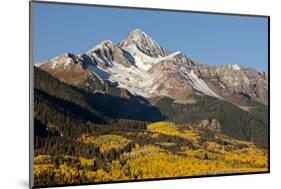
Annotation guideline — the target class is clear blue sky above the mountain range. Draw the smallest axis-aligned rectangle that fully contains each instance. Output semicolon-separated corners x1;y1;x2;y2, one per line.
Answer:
33;3;268;71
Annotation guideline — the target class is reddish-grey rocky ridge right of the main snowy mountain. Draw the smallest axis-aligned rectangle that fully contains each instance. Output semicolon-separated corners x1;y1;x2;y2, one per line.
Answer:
190;65;268;106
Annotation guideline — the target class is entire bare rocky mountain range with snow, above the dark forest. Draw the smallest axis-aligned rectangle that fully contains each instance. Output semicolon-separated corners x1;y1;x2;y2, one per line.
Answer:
38;29;268;111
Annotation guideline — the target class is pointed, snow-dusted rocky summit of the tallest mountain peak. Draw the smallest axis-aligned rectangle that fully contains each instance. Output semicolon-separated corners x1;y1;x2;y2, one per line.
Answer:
119;29;169;58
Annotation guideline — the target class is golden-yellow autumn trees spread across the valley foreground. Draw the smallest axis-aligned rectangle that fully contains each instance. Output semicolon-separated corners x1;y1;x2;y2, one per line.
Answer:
34;122;268;184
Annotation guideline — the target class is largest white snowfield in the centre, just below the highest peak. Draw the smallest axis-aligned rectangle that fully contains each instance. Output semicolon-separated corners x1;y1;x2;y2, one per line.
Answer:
85;50;186;98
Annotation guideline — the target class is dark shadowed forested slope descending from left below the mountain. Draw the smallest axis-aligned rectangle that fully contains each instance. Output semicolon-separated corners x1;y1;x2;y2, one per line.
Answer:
34;67;165;124
